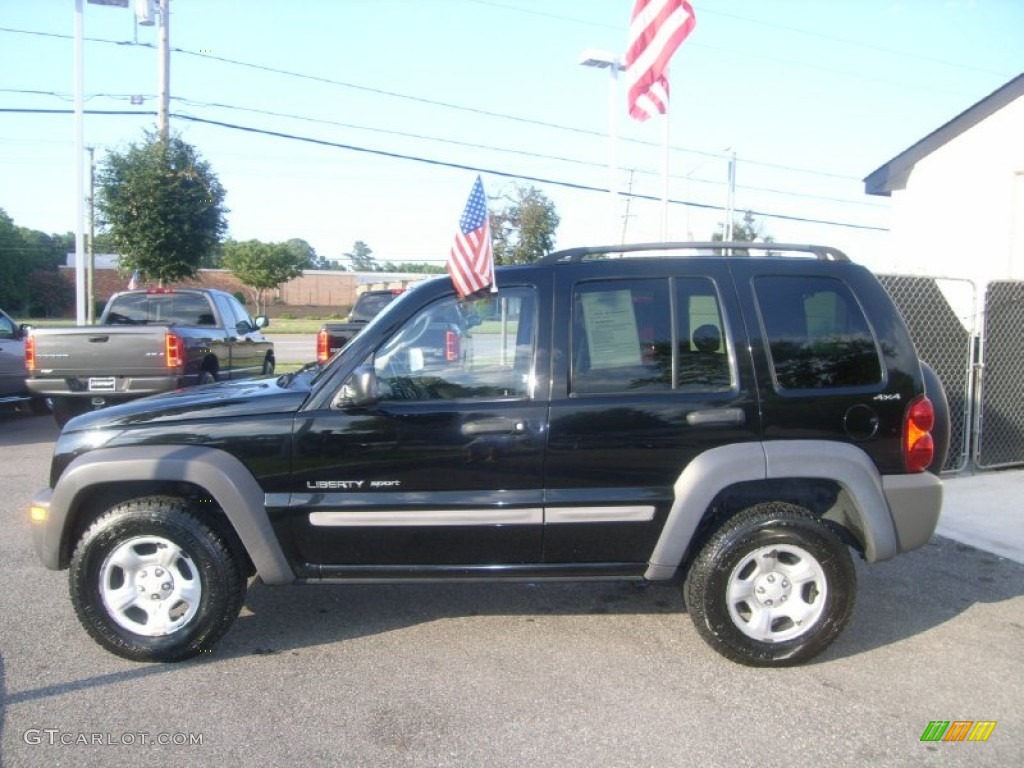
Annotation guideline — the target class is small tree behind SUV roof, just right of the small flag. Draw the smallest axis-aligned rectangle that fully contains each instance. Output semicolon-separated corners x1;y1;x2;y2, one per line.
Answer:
490;184;560;264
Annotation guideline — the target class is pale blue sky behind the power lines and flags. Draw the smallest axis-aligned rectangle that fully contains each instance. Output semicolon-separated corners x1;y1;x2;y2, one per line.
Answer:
0;0;1024;270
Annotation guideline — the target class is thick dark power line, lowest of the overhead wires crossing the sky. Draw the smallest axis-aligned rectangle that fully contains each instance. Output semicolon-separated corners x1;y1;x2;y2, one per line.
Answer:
0;108;888;231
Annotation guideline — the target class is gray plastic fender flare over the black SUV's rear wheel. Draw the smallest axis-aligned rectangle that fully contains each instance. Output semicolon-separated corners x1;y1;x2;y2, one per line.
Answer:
645;440;899;581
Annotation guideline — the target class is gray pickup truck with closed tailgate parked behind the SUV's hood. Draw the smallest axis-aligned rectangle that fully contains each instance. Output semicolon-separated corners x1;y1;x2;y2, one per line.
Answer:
25;289;274;426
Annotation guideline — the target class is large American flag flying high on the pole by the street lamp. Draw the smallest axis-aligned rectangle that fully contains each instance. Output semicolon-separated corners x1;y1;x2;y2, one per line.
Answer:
626;0;697;120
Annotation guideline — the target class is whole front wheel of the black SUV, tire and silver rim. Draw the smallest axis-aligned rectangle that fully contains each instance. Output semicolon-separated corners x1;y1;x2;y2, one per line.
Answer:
70;497;246;662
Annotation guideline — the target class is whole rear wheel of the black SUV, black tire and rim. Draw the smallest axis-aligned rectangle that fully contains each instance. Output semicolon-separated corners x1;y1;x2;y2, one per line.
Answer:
683;502;857;667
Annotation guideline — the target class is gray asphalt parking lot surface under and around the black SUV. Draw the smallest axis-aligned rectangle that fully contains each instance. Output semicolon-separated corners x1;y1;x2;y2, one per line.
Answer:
0;414;1024;768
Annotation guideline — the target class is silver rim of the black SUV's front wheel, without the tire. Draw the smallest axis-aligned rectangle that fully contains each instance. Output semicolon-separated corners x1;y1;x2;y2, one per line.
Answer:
99;536;203;637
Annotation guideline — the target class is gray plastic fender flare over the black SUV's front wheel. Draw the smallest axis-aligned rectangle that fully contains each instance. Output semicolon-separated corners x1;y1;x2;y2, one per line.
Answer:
50;445;295;584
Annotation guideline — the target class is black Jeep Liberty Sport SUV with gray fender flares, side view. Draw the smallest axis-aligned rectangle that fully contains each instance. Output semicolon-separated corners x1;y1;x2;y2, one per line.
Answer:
32;243;947;666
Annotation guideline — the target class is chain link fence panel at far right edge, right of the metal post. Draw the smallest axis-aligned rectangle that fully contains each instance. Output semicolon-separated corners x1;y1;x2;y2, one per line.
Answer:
976;281;1024;469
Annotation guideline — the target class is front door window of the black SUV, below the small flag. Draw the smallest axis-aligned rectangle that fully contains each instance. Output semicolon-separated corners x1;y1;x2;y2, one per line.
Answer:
373;288;537;400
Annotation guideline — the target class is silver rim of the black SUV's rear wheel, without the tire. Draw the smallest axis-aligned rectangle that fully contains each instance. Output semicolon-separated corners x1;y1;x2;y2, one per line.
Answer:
726;544;828;643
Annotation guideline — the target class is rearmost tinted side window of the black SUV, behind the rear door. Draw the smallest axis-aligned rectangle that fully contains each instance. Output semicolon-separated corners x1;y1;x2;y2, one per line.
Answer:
754;276;882;389
